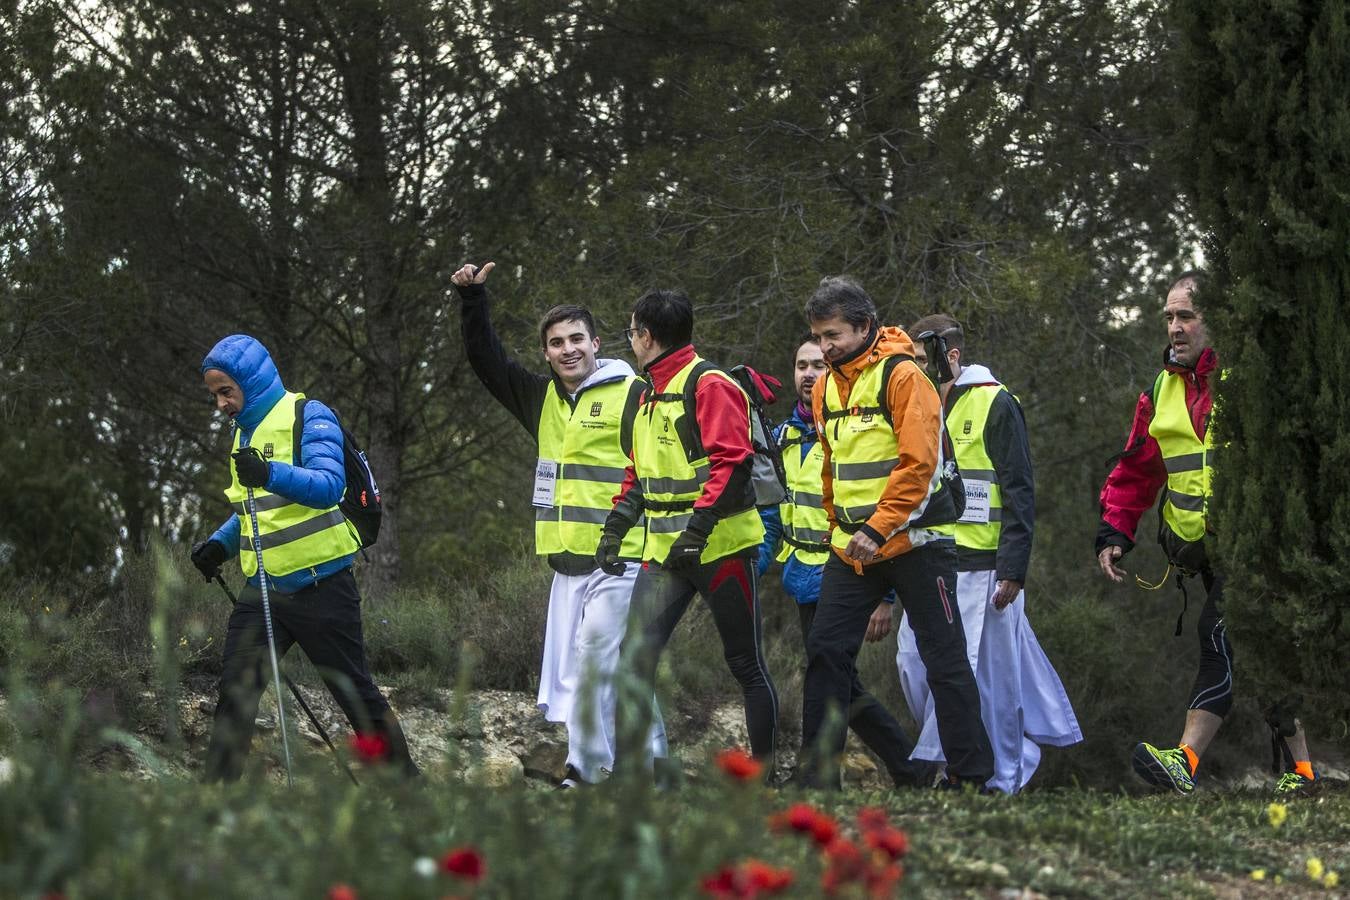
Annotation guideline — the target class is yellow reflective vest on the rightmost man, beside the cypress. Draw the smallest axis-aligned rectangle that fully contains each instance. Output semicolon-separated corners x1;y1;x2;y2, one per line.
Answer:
1149;372;1214;542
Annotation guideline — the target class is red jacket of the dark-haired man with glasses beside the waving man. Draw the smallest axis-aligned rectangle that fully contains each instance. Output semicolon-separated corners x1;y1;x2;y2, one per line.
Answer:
614;344;755;510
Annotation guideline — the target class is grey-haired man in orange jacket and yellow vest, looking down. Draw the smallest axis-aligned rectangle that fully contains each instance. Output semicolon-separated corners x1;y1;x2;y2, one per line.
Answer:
801;277;994;787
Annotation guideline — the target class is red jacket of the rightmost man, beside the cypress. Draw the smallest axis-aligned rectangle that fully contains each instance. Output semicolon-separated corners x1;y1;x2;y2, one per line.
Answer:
1096;347;1219;553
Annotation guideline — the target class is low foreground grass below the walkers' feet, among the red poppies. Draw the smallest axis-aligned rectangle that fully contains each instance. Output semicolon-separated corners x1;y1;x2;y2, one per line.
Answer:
0;699;1350;900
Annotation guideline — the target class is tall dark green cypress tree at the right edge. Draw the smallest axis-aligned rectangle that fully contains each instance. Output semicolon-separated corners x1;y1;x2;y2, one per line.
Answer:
1180;0;1350;734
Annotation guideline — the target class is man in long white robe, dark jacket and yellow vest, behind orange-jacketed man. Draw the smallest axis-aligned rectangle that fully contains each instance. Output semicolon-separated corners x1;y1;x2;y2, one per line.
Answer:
896;314;1083;793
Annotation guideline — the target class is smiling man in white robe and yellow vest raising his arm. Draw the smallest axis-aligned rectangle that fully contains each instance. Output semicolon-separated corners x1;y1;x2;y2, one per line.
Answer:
451;262;666;788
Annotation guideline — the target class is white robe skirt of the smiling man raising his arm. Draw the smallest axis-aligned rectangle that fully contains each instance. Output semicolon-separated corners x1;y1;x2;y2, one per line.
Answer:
539;563;668;781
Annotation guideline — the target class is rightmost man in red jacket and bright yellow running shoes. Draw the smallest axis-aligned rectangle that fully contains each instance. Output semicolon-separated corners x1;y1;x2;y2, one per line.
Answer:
1096;271;1315;793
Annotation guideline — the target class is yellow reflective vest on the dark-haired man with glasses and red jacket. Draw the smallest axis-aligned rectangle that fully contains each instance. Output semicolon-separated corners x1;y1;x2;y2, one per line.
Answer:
633;356;764;563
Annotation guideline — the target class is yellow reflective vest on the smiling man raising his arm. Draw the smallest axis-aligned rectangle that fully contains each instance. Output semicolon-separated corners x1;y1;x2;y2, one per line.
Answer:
535;375;643;560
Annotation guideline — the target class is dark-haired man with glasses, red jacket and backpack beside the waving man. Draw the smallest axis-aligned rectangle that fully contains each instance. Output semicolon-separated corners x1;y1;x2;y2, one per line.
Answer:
597;290;778;777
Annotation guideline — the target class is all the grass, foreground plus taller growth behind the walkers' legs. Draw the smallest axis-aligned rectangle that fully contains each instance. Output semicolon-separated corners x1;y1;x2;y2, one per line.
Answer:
0;545;1350;899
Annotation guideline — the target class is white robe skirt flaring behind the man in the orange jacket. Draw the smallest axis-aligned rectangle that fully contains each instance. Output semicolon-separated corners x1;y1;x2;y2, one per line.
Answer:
895;569;1083;793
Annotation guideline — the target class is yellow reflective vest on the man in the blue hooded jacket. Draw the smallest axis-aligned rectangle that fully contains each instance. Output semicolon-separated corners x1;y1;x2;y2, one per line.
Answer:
225;391;360;578
